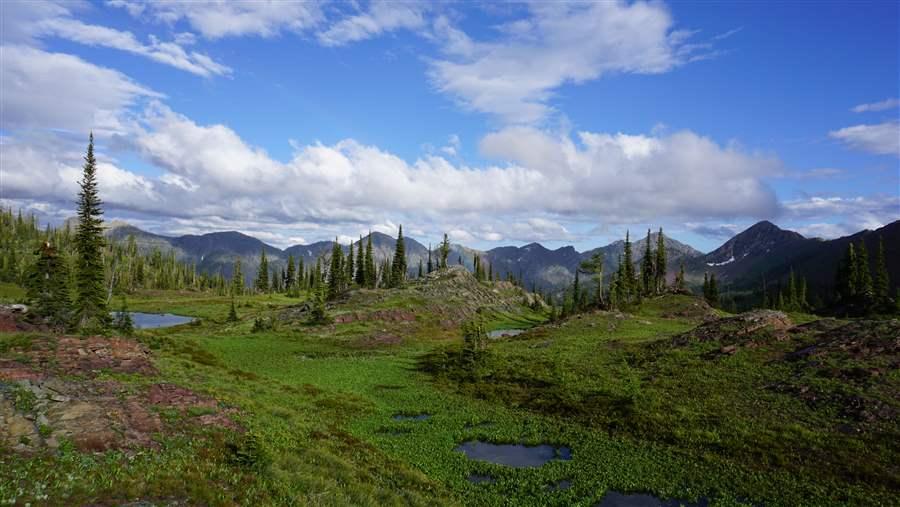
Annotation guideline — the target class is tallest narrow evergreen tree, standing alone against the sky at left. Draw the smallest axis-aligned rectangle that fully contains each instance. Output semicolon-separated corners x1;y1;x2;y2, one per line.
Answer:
75;133;110;330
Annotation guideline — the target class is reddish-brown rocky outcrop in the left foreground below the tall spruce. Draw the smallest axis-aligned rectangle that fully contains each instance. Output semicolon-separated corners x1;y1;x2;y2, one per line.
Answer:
0;336;238;453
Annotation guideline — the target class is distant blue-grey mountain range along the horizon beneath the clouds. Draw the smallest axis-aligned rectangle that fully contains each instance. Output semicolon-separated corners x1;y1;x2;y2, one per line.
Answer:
107;220;900;306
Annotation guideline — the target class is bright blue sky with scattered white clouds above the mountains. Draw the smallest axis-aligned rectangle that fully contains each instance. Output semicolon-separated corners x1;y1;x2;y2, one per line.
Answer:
0;0;900;250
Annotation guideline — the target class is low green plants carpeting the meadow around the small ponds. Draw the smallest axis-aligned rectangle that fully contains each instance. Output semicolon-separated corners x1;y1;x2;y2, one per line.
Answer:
0;291;900;505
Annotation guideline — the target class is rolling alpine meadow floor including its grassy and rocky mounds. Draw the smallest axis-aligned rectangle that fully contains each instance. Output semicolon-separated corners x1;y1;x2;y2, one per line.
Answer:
0;268;900;505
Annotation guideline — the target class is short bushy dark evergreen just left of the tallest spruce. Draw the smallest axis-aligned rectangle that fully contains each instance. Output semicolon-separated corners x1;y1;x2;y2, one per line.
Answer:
27;241;72;327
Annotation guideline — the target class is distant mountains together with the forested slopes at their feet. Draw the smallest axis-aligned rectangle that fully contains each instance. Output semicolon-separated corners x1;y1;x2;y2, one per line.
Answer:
0;204;900;314
